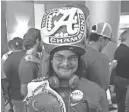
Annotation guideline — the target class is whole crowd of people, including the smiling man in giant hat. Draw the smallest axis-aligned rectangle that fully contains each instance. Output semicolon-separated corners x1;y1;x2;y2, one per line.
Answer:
1;5;129;112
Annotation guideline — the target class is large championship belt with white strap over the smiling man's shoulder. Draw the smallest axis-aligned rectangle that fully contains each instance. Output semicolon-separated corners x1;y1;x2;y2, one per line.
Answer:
24;80;66;112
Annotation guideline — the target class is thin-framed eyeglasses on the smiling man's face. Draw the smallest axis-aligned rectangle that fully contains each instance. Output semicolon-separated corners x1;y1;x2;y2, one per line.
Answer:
53;55;78;62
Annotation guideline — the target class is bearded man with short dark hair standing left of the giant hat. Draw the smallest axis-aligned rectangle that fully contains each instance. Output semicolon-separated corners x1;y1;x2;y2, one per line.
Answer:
19;28;42;97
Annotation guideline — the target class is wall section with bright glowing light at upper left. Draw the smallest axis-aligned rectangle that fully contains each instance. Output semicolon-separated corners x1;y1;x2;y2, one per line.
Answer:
6;1;35;41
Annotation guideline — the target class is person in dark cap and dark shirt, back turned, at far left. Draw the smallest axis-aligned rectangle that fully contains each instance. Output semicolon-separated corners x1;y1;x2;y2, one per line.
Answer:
3;37;25;112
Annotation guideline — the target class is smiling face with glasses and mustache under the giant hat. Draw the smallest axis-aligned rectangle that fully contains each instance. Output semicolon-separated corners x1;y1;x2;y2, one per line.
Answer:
51;50;78;79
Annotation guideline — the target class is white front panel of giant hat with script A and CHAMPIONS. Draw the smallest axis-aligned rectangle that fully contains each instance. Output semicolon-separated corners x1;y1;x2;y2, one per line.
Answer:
41;7;85;45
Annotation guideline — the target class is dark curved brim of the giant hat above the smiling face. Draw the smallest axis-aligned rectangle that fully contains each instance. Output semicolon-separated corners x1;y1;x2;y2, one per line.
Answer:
50;45;86;55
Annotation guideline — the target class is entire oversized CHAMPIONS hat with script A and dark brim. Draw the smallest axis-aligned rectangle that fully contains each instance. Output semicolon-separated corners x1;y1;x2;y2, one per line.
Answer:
41;6;88;55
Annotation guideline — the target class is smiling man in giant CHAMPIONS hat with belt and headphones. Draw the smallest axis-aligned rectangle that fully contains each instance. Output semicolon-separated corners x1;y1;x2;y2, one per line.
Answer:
25;7;108;112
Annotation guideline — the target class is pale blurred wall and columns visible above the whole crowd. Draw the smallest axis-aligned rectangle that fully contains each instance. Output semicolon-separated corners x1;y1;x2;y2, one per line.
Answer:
1;0;129;60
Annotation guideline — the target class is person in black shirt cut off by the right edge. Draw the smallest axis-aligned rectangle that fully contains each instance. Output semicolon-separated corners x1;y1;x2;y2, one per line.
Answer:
114;30;129;112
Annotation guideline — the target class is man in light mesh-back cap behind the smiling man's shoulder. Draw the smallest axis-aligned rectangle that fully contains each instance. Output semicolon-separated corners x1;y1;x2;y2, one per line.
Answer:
83;22;115;91
